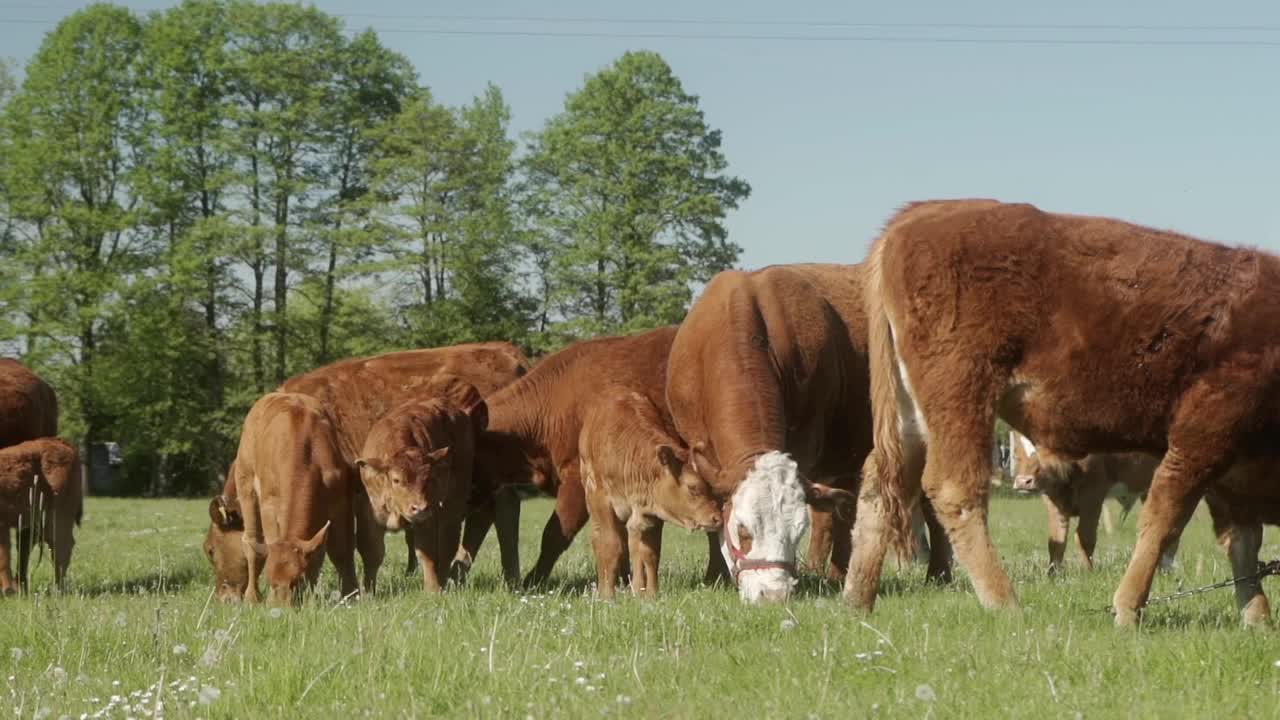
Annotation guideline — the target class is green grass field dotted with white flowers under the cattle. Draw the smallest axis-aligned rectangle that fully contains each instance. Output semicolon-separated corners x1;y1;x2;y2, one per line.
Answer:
0;497;1280;719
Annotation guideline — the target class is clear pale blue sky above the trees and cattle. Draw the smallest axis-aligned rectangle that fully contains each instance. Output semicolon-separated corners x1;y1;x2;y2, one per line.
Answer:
0;0;1280;266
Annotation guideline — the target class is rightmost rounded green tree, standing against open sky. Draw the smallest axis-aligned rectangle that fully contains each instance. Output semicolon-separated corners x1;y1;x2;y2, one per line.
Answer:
526;51;750;336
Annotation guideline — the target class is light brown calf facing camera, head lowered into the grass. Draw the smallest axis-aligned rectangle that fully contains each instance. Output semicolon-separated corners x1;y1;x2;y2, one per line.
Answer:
232;392;358;605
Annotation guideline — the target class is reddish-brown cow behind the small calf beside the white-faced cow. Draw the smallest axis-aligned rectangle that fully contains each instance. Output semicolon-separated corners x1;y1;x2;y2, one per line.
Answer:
462;327;721;585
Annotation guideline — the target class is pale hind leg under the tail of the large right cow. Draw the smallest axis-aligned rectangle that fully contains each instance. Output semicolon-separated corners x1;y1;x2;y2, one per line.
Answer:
844;427;925;612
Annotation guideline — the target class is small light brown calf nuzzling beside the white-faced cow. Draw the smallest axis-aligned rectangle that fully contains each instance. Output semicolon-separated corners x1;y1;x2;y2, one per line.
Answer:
579;389;721;600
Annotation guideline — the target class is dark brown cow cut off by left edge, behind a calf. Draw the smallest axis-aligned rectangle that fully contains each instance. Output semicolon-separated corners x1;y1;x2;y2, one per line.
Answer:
0;357;58;592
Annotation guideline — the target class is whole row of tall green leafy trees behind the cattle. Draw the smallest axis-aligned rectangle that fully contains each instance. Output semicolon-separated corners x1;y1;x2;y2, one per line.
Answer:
0;0;750;493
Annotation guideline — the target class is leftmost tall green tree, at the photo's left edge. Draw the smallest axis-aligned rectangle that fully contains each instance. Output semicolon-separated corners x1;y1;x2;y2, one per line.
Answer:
4;5;151;442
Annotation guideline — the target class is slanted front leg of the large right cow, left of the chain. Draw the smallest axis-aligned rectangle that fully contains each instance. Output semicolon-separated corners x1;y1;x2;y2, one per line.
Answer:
1112;445;1226;625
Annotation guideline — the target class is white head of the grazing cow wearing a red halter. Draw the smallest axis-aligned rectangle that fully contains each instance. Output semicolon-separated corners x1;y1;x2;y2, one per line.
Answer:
721;451;856;602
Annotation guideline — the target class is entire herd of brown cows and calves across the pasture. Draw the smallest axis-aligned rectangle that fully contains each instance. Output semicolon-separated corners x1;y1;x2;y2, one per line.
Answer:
0;200;1280;624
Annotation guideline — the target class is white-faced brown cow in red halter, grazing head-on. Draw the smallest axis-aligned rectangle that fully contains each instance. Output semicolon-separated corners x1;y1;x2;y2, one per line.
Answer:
667;265;947;602
